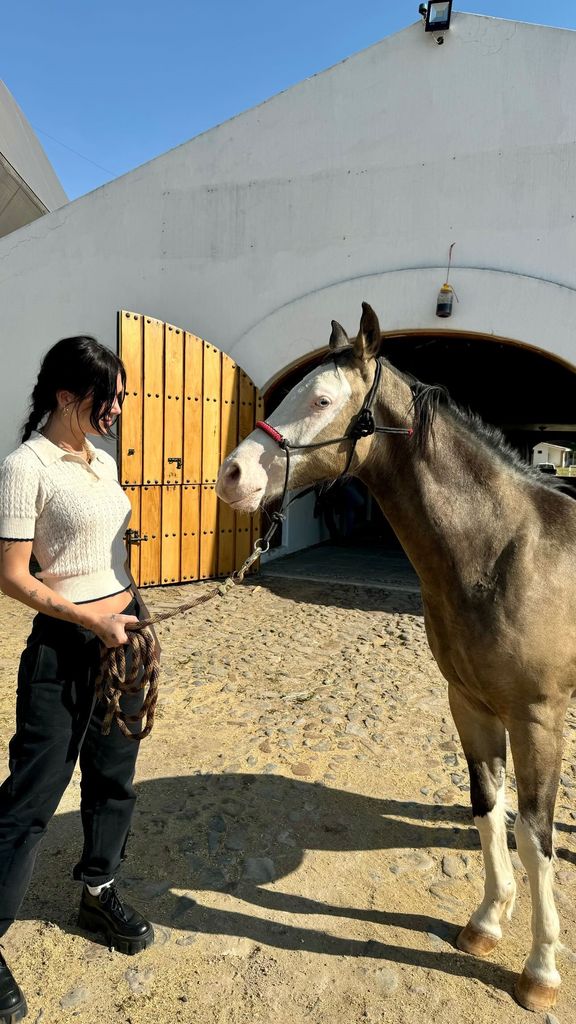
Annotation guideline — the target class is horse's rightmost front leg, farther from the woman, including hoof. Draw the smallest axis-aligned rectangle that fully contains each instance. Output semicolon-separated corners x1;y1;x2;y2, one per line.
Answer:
509;709;564;1011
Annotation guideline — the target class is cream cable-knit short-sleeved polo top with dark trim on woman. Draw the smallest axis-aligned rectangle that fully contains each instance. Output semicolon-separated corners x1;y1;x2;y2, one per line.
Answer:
0;430;131;604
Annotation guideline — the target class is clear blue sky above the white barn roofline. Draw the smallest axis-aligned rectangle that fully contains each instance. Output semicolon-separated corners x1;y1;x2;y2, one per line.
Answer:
1;0;576;199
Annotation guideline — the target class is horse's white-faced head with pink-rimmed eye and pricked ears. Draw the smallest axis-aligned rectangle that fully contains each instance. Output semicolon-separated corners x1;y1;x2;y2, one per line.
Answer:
216;302;380;512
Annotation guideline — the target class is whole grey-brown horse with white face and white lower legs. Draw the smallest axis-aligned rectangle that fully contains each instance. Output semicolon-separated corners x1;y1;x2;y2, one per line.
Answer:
216;303;576;1011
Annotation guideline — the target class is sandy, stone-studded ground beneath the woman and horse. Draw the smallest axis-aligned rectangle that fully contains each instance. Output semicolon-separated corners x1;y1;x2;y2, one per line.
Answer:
0;578;576;1024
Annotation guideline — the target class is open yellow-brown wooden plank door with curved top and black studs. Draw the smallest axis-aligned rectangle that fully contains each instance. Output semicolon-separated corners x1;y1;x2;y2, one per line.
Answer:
119;310;262;587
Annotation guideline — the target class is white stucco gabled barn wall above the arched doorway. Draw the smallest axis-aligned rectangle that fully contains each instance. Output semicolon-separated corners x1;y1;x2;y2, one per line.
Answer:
0;13;576;456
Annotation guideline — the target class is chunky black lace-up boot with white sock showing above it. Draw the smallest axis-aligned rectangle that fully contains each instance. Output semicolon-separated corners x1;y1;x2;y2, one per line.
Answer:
78;885;154;955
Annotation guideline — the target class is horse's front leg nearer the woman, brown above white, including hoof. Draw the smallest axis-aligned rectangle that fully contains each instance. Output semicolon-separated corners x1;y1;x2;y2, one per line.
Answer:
449;685;516;956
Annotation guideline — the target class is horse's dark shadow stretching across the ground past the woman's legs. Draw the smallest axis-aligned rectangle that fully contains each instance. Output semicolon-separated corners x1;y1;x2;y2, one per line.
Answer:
23;774;524;990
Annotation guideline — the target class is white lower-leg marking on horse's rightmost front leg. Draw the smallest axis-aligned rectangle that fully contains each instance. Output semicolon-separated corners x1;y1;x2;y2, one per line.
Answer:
515;814;561;988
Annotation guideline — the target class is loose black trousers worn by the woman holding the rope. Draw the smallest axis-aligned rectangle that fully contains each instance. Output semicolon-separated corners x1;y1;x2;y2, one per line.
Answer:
0;598;142;936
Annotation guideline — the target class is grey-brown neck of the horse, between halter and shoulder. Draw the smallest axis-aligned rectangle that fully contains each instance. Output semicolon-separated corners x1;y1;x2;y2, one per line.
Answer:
358;375;521;586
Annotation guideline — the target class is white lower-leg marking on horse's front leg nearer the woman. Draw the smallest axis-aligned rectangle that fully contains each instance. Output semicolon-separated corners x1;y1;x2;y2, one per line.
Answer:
470;779;516;939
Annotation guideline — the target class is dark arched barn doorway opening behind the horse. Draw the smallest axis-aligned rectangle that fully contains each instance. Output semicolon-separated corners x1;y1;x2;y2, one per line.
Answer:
264;332;576;552
